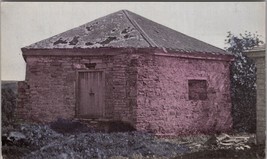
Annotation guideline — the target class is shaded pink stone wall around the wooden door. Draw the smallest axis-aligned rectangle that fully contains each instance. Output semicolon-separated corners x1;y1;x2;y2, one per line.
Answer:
17;52;137;123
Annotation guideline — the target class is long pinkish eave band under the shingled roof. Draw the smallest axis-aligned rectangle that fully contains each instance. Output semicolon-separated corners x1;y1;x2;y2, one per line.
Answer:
21;47;237;61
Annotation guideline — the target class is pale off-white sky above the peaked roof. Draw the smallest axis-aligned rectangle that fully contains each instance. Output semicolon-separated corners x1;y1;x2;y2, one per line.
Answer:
1;2;266;80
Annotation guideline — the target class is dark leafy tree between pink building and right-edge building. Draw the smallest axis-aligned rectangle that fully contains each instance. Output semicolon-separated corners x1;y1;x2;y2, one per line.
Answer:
225;32;263;132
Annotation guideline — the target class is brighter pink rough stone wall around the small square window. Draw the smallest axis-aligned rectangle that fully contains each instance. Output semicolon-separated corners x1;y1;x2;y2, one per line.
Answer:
136;55;232;136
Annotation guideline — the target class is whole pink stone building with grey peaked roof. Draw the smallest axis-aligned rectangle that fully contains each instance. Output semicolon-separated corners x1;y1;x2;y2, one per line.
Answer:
17;10;233;135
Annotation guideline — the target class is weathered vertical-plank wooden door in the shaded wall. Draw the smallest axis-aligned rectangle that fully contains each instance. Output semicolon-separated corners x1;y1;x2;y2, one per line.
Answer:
78;71;104;118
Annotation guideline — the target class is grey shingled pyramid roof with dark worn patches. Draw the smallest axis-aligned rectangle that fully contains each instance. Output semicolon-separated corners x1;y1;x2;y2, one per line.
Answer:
24;10;228;54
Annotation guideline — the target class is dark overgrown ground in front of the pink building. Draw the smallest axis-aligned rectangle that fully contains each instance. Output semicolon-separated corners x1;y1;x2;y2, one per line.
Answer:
2;120;265;159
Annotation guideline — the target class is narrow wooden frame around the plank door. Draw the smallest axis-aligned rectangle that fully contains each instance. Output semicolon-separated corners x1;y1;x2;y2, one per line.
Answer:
75;69;106;119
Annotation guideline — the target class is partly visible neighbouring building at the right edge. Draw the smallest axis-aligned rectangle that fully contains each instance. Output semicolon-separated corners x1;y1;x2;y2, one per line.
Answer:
245;45;266;144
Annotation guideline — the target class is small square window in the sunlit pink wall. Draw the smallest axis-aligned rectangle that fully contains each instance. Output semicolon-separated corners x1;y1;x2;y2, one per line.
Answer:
188;80;207;100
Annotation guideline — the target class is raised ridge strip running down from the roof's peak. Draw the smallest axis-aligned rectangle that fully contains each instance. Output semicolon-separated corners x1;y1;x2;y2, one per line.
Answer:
122;10;158;47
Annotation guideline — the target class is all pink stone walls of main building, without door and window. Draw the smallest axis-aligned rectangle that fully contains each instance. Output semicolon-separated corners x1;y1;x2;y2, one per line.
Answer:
17;50;232;136
